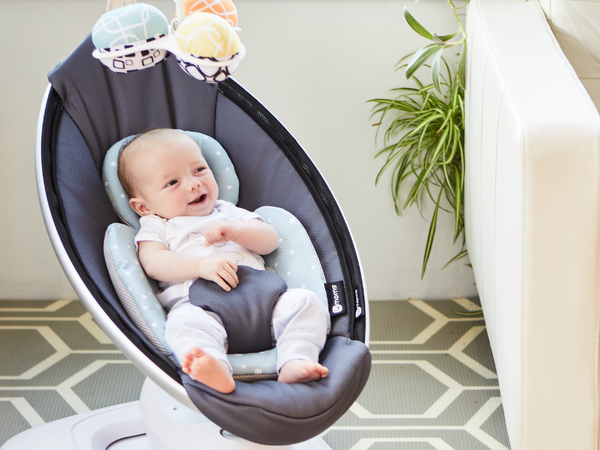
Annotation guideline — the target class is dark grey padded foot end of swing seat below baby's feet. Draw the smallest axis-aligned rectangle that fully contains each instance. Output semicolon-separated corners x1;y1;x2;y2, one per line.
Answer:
181;336;371;445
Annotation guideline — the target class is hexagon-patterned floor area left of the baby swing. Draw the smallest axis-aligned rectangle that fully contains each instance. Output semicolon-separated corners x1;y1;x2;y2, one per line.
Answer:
0;300;144;445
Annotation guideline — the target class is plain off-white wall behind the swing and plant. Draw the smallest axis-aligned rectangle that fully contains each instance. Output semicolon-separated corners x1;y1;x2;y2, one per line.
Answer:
0;0;476;299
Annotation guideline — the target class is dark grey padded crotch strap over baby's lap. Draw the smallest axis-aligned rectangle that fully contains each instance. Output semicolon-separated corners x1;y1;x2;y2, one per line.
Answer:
190;266;287;353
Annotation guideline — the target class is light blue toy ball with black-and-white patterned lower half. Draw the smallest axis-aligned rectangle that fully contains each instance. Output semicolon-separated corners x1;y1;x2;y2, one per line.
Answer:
92;3;169;73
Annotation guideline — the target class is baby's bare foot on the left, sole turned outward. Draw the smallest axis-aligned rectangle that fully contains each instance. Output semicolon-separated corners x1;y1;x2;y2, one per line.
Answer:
181;347;235;394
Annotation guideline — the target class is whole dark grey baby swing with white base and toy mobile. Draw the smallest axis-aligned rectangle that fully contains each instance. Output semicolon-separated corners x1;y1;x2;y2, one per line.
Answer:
2;0;371;450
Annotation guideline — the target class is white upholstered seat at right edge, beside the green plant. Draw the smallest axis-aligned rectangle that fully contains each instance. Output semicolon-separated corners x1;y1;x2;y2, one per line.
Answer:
465;0;600;450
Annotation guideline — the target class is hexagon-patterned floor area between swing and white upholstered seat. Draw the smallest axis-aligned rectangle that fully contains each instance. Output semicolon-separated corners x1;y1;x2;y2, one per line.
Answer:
323;298;510;450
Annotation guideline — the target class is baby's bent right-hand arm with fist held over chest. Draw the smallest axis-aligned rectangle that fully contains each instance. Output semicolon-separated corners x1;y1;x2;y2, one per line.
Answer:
204;219;279;255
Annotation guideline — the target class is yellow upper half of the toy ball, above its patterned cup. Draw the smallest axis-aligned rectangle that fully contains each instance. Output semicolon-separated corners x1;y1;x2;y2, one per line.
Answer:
175;12;240;58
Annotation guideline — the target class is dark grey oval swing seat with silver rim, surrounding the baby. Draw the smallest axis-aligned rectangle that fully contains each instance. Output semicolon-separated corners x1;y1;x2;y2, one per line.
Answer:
27;29;371;446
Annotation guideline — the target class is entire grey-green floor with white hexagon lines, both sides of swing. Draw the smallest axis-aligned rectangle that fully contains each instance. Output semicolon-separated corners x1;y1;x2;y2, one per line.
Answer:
0;299;510;450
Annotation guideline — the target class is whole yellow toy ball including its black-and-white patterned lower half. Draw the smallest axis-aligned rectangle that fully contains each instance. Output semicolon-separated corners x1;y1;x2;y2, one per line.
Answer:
175;12;245;83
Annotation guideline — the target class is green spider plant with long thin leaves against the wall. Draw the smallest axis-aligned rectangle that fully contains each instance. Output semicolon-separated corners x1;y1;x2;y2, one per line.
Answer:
369;0;469;278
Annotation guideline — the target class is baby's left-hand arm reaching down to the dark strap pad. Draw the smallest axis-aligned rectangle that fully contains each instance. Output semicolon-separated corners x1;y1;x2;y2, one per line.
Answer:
138;241;239;291
